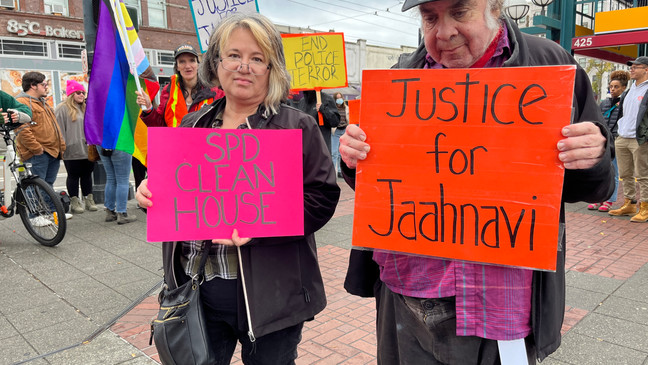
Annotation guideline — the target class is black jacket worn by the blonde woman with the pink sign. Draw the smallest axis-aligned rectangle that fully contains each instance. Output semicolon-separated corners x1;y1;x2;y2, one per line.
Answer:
162;98;340;338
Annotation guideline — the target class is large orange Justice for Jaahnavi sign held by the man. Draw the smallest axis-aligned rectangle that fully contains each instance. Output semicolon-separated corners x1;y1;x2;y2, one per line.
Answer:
353;66;576;270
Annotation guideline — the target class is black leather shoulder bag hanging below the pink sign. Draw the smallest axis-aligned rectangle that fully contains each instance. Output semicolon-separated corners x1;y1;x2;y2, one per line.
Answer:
151;240;216;365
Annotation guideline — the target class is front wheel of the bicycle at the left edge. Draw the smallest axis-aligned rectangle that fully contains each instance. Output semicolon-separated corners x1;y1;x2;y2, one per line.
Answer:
16;177;67;247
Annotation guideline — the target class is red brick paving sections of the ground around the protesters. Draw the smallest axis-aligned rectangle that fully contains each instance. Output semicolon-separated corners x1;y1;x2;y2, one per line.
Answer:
111;181;648;364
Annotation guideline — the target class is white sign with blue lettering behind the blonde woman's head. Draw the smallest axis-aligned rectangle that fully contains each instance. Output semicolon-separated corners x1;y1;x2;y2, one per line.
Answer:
189;0;259;53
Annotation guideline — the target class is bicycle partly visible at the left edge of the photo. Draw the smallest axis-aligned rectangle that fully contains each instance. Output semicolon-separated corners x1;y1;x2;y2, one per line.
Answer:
0;111;67;247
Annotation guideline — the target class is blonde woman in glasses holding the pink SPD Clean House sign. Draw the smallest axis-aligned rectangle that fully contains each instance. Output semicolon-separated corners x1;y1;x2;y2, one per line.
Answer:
136;14;340;364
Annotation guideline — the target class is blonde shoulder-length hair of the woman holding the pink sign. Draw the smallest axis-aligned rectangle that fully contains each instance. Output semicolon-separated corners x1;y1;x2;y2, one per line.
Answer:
199;13;290;114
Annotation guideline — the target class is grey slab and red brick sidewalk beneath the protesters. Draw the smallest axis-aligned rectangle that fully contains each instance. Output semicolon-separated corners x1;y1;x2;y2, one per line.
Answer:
0;180;648;365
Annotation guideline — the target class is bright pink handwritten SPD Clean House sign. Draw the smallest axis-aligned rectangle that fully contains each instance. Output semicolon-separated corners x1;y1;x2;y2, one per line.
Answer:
146;128;304;242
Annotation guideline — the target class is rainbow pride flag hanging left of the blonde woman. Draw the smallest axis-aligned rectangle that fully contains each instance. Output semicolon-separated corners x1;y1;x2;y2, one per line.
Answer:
85;0;159;165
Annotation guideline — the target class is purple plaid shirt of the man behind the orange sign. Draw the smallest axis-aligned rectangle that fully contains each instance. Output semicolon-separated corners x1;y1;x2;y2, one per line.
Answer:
373;25;533;340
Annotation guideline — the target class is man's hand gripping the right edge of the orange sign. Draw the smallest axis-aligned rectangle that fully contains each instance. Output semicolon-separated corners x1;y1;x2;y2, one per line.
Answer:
558;122;606;170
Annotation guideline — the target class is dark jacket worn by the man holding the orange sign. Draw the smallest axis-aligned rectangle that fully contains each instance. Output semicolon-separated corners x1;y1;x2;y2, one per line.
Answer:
342;19;614;360
